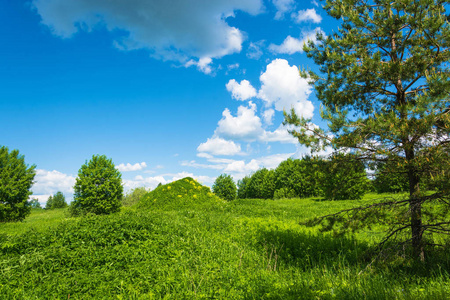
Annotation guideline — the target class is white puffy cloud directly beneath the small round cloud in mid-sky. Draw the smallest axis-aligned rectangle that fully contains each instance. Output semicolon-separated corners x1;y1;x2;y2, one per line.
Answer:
215;102;263;141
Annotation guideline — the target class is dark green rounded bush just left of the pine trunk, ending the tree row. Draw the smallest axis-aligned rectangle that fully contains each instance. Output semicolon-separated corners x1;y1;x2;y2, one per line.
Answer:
320;154;369;200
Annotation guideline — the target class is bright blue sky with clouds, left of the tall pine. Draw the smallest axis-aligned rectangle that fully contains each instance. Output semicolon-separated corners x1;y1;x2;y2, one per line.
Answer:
0;0;338;203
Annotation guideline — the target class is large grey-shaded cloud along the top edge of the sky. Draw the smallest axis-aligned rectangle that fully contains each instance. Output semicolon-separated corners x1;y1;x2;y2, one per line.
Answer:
32;0;263;73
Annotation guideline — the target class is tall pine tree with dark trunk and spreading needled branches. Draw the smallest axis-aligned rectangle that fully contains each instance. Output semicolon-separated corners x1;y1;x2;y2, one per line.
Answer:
285;0;450;260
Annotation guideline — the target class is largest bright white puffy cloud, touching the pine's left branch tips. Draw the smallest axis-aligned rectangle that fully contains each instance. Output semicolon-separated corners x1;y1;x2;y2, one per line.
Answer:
258;59;314;118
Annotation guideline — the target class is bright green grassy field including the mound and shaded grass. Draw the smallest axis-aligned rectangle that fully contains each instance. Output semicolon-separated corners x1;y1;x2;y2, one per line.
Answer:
0;178;450;299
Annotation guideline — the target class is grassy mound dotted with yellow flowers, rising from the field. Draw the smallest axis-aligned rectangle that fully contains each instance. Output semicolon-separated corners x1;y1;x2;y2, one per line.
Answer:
138;177;224;209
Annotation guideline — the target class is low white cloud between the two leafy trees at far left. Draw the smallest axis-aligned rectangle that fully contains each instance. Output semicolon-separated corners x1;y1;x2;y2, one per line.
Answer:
31;169;75;196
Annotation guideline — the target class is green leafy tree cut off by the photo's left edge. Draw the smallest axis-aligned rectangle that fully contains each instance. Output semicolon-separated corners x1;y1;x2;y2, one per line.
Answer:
0;146;35;222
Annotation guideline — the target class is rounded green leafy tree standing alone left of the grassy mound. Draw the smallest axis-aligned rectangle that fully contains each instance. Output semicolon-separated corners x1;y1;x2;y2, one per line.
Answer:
70;155;123;215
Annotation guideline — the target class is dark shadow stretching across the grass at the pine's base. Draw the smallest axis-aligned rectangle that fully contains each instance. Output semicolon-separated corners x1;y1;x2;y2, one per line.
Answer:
258;224;450;278
